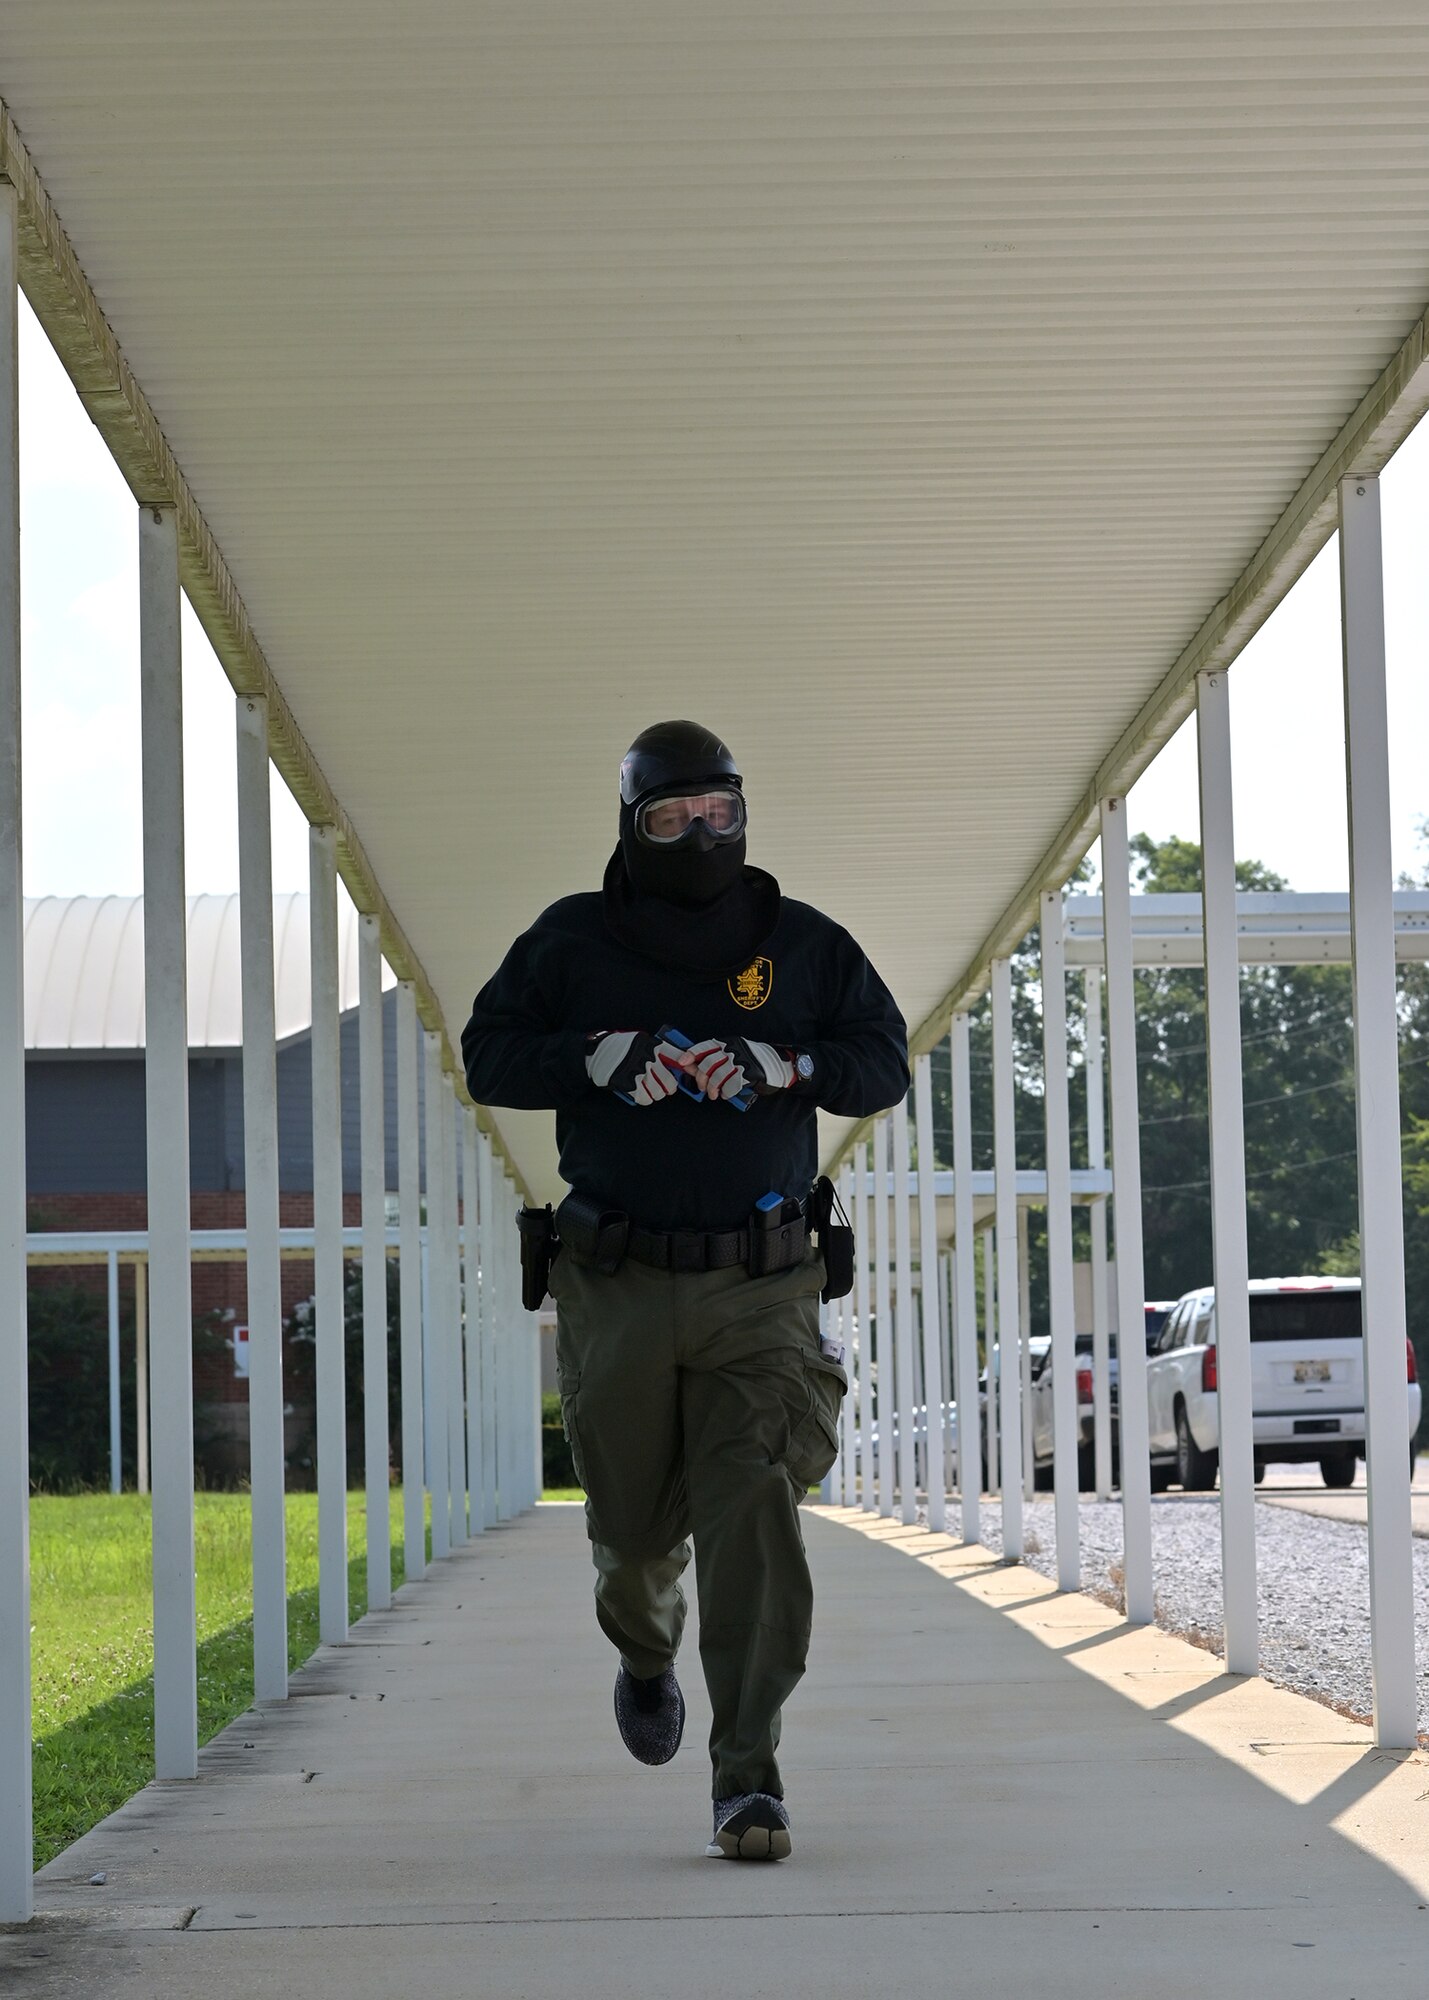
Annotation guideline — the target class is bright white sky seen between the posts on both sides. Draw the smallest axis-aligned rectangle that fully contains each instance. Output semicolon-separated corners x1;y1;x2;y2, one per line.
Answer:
20;300;1429;896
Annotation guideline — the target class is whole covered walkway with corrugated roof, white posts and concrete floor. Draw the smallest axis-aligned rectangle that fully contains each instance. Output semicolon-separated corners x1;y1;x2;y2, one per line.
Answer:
0;0;1429;1968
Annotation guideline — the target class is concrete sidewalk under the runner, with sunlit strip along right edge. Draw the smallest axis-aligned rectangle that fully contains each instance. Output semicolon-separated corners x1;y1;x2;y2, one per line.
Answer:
0;1508;1429;2000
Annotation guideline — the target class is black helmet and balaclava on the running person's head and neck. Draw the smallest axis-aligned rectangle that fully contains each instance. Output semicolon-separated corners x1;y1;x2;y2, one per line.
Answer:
604;722;779;978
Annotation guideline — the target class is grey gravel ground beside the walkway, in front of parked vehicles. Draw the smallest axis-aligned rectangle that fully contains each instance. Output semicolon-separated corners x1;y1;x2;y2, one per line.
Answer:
968;1494;1429;1730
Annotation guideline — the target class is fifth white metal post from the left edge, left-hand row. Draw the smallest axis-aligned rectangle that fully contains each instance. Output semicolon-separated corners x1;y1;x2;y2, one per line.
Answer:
358;914;392;1610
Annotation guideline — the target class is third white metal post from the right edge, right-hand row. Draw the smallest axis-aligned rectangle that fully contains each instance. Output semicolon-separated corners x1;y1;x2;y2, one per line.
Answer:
1101;798;1155;1624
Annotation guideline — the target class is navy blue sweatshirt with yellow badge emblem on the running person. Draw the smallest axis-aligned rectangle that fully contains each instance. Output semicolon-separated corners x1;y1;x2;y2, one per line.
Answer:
462;894;909;1230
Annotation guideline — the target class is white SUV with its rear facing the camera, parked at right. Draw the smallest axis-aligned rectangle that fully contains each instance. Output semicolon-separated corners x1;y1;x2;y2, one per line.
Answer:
1147;1278;1419;1492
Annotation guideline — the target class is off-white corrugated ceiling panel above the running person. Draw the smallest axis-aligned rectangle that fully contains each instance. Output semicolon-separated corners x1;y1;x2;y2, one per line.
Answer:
0;0;1429;1180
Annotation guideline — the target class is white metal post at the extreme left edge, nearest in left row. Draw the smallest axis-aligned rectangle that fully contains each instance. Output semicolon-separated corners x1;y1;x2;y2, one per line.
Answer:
0;180;29;1924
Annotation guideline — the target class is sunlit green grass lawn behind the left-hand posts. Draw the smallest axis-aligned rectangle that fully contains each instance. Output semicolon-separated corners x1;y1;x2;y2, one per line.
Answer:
30;1490;430;1868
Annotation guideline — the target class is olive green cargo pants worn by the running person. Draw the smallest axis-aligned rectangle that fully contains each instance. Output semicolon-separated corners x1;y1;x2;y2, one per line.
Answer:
550;1250;849;1798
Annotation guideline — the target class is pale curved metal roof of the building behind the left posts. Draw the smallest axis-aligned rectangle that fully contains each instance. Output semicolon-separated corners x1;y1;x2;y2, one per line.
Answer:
24;894;378;1050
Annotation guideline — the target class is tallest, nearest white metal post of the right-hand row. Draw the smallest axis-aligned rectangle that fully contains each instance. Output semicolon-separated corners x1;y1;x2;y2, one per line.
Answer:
1339;478;1419;1750
